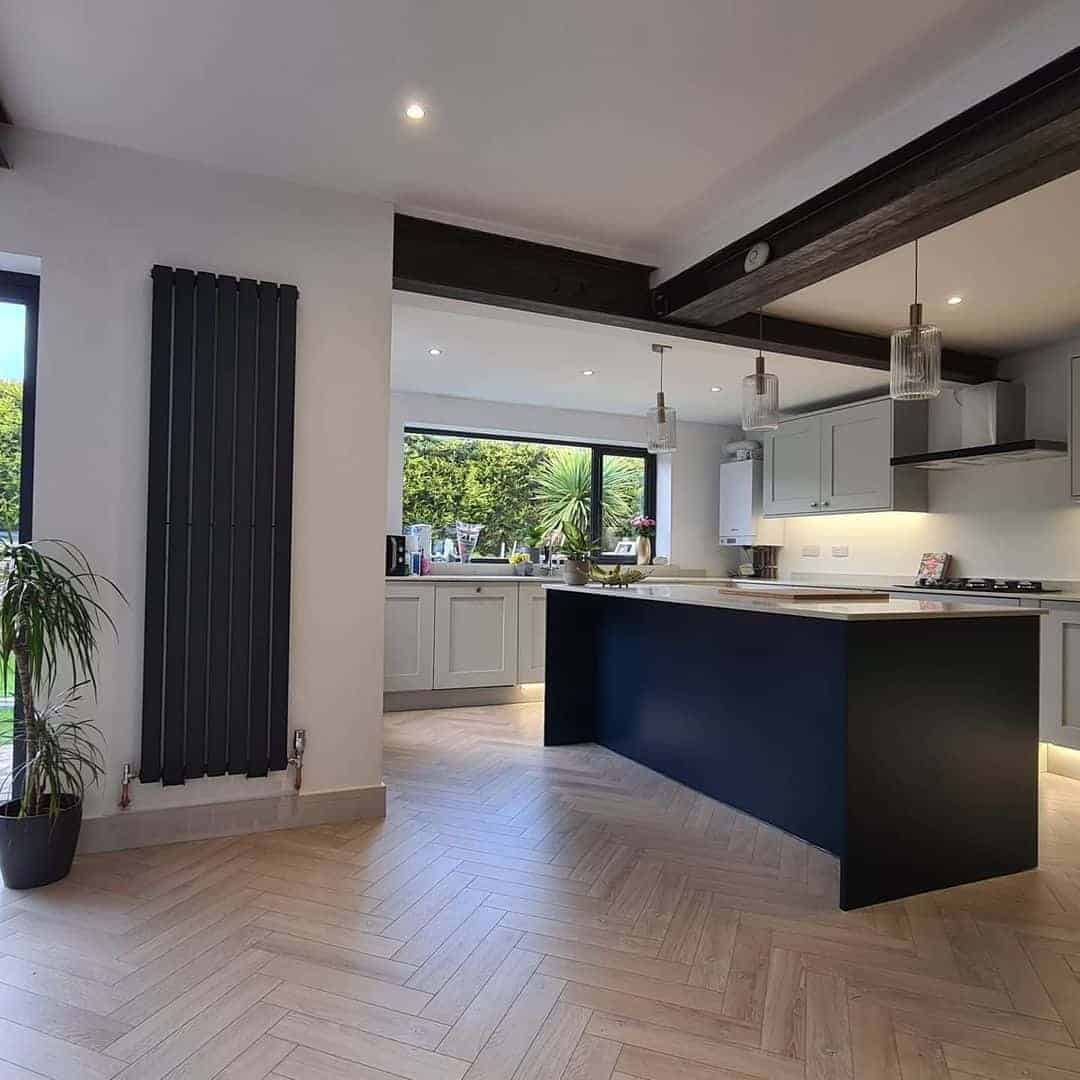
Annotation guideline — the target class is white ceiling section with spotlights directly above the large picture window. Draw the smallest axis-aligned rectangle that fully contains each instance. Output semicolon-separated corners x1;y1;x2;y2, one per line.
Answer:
391;292;889;424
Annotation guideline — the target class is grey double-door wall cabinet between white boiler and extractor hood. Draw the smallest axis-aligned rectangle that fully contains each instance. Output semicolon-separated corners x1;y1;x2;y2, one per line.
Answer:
764;397;928;517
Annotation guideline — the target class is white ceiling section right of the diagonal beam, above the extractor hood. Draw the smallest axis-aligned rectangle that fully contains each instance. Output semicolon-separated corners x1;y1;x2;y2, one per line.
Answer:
767;173;1080;356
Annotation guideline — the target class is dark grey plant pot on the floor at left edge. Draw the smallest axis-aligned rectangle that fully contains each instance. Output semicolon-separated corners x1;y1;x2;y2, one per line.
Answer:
0;795;82;889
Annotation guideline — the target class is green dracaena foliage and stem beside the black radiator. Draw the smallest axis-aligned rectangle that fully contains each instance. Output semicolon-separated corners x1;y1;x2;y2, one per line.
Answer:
0;540;124;816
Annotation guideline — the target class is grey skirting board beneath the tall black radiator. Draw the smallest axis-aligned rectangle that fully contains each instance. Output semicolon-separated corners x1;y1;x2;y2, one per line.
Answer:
79;784;387;854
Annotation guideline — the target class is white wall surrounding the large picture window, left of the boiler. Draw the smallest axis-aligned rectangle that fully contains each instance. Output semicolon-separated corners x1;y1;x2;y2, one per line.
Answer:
387;393;742;573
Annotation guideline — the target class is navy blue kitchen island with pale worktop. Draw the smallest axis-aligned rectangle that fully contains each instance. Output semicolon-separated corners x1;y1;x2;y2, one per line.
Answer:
544;585;1041;909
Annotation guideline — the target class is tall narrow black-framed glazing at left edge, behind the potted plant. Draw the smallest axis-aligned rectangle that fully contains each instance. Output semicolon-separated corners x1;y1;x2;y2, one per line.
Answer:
0;271;38;791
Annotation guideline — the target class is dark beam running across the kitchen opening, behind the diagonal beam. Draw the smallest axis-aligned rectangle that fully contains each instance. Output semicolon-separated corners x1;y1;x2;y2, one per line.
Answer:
394;214;997;382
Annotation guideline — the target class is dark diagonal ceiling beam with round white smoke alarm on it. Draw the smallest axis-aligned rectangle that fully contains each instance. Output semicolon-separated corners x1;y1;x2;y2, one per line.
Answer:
653;48;1080;325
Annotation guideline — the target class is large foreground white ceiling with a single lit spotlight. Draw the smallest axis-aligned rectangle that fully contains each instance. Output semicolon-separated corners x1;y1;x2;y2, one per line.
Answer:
0;0;1049;261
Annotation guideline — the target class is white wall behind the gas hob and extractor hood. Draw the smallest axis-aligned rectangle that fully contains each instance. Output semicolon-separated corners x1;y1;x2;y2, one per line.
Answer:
781;335;1080;580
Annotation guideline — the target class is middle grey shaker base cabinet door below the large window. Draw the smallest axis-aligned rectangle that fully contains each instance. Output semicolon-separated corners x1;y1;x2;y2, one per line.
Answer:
432;583;517;690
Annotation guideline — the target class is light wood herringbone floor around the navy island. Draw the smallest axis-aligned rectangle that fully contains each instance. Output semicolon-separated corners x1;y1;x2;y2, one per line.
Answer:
0;705;1080;1080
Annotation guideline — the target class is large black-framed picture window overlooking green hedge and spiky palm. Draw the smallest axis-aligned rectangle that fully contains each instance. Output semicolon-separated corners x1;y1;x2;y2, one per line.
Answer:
402;428;657;563
